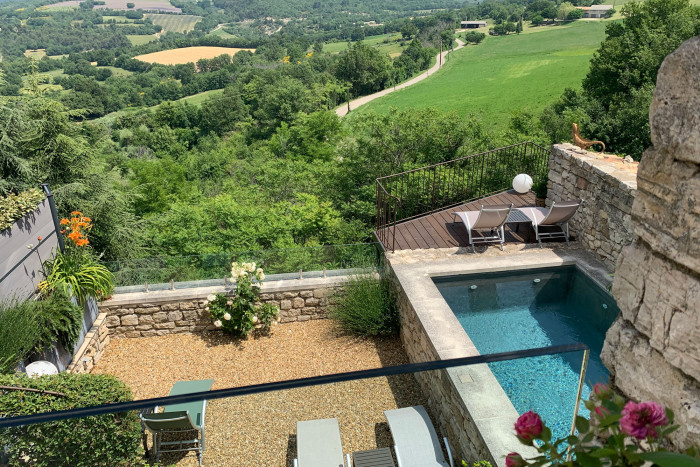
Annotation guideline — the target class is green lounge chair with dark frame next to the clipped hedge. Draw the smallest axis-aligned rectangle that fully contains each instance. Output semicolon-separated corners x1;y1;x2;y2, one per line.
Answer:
139;379;214;465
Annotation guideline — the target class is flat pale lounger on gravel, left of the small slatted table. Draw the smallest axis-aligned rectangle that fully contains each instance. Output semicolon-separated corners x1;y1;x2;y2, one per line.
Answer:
294;418;352;467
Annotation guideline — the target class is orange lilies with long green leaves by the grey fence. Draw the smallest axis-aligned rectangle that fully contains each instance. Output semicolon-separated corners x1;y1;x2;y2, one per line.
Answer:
39;211;114;304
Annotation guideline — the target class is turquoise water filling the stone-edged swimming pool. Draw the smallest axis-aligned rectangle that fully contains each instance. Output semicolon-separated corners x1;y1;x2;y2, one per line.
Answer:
433;266;619;437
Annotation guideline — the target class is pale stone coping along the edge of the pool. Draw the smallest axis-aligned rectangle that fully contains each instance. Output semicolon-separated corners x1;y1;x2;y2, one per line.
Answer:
387;245;612;466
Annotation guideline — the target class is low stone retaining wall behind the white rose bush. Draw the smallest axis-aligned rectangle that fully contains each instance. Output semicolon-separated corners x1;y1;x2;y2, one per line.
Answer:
100;276;347;337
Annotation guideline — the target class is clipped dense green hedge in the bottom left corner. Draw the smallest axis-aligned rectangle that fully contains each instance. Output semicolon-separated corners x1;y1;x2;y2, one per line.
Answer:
0;373;144;467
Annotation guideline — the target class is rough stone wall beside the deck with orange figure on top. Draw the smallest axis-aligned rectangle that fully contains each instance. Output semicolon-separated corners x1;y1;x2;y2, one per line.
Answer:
547;143;638;270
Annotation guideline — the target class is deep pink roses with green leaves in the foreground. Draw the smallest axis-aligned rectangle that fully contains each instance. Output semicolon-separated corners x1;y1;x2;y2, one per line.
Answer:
506;383;700;467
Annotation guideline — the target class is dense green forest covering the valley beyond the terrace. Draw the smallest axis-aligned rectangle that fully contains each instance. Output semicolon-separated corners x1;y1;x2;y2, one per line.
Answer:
0;0;700;284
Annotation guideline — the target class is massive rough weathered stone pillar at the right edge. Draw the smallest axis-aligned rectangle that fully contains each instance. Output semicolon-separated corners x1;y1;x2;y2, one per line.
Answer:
602;36;700;448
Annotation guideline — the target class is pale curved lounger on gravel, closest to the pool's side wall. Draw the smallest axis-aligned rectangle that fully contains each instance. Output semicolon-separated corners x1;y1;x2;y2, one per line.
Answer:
384;405;454;467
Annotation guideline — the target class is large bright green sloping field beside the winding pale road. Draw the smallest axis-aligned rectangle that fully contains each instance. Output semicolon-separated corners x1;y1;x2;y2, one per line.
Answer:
348;21;609;128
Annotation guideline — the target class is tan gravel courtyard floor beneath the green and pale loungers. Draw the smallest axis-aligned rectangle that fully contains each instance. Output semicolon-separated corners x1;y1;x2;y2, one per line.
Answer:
93;320;425;467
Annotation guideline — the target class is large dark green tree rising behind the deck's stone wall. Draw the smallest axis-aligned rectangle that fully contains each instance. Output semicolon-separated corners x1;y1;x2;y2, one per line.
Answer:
543;0;700;159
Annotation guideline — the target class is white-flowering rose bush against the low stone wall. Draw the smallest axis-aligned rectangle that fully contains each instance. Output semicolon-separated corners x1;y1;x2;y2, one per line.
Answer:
206;263;279;337
